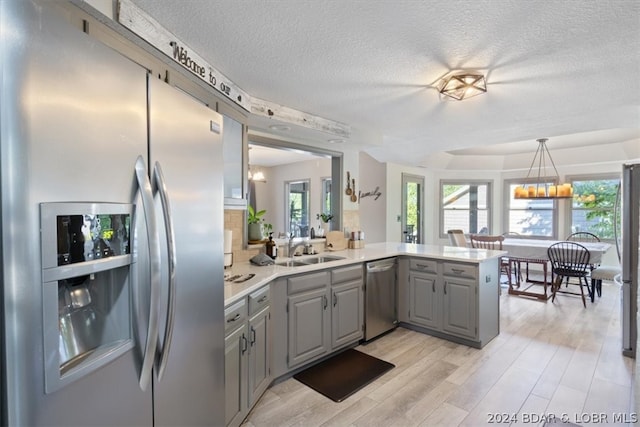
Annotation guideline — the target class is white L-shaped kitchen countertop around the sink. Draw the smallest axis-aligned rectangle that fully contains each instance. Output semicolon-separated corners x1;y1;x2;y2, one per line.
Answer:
224;242;507;306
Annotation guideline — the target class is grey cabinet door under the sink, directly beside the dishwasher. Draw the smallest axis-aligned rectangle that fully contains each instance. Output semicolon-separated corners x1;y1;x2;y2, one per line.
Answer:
331;280;363;348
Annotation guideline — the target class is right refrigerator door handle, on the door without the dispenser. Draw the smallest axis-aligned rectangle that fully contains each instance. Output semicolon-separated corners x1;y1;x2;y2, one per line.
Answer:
153;162;176;380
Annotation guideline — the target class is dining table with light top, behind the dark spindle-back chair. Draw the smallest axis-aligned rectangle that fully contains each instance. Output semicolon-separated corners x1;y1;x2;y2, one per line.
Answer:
502;237;611;301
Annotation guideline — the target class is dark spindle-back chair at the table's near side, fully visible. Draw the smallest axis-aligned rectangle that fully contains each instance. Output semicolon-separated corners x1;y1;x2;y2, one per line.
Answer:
547;241;593;308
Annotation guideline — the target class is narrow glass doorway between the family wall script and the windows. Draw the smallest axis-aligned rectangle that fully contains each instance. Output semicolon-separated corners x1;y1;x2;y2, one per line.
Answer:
400;173;424;243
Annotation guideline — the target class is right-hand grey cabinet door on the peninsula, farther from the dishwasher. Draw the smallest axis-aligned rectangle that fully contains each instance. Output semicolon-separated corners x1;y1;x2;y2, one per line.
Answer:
442;277;477;338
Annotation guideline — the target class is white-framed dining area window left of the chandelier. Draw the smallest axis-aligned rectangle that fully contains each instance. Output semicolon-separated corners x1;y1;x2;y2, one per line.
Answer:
440;181;491;238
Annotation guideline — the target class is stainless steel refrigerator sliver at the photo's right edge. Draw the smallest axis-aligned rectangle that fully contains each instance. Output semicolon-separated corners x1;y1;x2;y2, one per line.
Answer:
620;163;640;357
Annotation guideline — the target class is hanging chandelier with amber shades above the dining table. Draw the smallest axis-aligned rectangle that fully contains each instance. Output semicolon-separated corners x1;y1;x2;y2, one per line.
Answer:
513;138;573;199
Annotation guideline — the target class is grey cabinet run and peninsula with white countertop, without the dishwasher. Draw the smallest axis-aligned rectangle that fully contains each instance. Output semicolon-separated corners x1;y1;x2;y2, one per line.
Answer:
224;243;506;426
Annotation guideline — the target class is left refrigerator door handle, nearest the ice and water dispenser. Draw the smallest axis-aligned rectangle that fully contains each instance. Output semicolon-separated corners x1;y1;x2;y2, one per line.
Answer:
135;156;160;390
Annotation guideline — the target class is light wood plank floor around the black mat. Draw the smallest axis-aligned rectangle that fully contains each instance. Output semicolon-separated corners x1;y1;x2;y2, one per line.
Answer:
244;282;635;427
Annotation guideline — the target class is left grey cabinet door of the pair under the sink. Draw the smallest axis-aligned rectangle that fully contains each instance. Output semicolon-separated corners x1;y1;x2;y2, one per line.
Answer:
288;287;330;367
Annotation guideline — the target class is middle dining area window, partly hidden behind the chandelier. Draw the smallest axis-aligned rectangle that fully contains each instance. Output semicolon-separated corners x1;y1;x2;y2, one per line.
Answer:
504;180;557;237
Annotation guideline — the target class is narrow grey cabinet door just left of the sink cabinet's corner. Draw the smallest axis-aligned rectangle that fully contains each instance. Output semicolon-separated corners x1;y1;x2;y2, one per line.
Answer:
249;308;270;406
